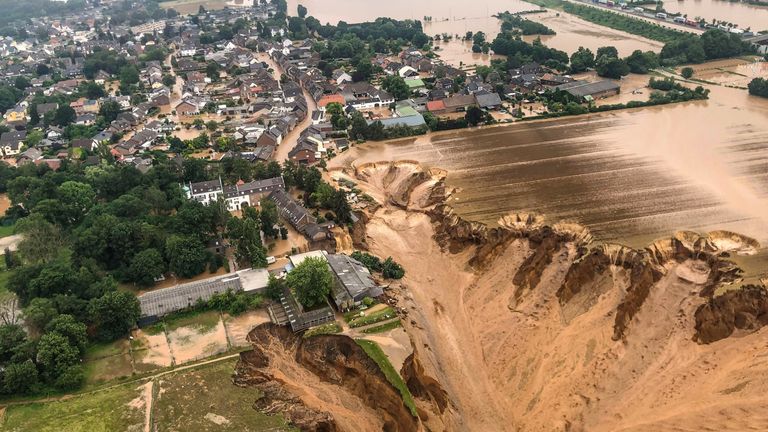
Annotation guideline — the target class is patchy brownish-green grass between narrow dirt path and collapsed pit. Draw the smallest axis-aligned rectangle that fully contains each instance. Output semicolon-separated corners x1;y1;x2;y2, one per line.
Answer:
153;359;295;432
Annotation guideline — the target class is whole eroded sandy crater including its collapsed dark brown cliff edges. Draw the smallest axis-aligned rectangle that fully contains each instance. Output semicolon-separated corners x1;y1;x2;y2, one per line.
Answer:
238;161;768;431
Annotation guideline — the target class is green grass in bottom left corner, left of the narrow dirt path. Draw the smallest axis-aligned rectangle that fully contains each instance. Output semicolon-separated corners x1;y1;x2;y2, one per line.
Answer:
2;383;145;432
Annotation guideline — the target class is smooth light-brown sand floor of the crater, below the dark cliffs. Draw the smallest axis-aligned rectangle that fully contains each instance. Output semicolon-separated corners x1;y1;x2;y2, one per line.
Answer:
332;164;768;431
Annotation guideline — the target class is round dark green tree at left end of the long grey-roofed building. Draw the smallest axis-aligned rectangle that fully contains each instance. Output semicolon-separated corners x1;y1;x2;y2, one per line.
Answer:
88;291;141;341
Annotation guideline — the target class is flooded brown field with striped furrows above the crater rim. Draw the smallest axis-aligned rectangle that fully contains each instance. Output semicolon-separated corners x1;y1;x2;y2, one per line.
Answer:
333;87;768;253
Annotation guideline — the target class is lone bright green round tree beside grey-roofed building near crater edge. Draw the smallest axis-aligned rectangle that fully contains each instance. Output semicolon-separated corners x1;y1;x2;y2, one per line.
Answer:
285;258;333;308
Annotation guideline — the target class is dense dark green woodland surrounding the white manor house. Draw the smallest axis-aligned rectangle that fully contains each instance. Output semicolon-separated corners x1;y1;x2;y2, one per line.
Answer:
0;154;351;393
